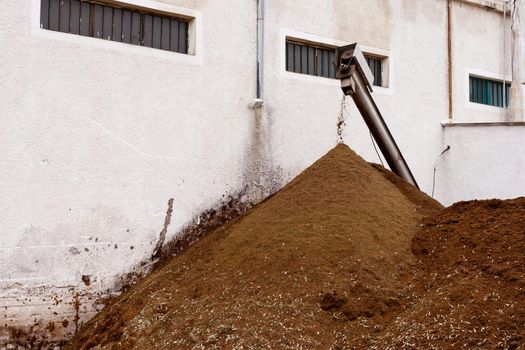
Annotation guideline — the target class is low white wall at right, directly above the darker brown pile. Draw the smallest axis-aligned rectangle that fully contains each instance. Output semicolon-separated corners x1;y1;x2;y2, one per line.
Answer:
435;123;525;205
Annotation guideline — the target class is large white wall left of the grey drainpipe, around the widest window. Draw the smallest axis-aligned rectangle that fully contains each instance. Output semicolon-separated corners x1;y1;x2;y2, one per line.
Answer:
0;0;257;343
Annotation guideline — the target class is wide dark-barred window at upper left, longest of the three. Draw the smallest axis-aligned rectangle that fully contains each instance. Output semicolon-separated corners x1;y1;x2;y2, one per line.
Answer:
40;0;189;54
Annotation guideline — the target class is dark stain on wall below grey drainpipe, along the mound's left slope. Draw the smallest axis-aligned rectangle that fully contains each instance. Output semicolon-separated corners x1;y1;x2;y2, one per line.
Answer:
113;108;283;296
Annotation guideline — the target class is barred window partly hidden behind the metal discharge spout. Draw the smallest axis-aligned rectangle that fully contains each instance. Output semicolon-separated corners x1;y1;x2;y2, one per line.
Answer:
286;40;383;86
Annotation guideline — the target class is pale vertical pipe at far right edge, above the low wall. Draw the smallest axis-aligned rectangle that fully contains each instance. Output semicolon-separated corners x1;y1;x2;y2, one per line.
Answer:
509;0;525;121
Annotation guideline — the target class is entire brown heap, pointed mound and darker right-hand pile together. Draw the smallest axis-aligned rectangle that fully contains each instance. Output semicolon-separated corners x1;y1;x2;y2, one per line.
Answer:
66;145;525;349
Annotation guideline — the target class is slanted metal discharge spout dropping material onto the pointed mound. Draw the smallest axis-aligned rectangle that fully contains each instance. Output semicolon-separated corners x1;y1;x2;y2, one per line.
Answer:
336;44;419;189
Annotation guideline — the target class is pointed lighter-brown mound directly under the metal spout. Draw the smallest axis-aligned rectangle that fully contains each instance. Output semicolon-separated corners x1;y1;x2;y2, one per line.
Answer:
69;145;441;349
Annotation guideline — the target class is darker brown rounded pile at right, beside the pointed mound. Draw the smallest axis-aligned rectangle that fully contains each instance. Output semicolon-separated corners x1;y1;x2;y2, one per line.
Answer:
384;198;525;349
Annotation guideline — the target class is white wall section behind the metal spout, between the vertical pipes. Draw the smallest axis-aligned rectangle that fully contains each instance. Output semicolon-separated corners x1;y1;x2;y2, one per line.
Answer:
266;0;448;197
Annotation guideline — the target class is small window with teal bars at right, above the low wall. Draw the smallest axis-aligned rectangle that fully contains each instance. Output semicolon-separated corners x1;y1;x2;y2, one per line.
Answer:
469;76;510;108
